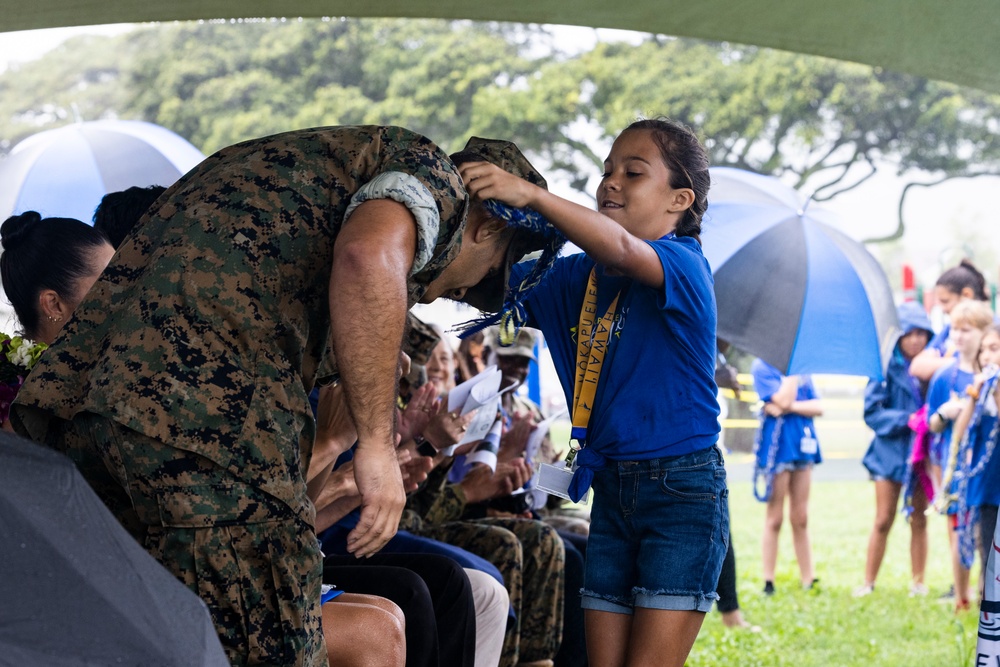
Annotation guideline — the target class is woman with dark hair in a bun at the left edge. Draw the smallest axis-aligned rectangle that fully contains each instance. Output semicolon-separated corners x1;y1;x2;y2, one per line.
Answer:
0;211;115;344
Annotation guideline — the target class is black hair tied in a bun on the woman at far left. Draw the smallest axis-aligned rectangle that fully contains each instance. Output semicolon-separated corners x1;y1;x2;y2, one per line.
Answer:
0;211;108;338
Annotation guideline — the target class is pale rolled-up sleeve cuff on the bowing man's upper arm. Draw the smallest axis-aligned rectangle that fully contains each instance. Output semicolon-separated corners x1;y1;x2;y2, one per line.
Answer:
344;171;441;276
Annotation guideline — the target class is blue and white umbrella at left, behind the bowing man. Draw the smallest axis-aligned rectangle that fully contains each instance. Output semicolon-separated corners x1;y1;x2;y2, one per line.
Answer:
0;120;204;222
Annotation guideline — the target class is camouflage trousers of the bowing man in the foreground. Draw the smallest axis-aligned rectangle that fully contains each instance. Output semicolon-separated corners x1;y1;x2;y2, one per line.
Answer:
57;414;327;667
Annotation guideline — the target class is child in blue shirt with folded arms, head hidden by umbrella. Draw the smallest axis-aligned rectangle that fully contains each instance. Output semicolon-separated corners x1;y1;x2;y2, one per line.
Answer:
750;359;823;595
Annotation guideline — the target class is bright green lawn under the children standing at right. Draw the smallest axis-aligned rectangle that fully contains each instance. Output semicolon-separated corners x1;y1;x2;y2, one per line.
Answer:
687;482;978;667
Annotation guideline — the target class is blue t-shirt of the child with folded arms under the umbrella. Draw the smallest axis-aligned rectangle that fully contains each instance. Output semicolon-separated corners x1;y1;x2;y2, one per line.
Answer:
750;359;823;468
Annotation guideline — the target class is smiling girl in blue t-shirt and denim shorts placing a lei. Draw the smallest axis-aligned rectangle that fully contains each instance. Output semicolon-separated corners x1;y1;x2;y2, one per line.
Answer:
460;119;729;667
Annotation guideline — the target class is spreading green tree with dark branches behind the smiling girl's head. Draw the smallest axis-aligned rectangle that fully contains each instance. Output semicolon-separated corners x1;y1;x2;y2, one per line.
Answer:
476;36;1000;239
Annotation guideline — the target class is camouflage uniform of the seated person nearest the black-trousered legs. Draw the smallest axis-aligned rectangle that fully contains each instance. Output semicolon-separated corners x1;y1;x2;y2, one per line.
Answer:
400;466;566;667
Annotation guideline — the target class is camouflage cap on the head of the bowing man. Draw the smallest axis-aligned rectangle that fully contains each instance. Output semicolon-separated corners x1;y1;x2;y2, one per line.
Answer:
450;137;549;313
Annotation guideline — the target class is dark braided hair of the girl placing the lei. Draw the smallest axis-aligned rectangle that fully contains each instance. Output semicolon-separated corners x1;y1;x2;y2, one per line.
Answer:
622;117;712;244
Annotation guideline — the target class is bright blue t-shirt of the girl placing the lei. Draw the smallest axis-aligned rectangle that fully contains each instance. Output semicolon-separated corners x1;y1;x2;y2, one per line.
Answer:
511;237;719;489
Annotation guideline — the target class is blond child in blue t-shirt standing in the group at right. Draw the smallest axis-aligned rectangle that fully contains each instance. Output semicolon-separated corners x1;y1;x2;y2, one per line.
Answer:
927;300;993;608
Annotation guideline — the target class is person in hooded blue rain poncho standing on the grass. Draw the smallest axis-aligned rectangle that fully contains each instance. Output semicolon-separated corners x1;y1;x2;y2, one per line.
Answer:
854;301;934;597
